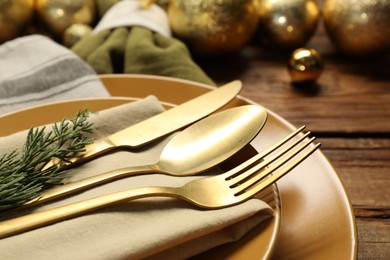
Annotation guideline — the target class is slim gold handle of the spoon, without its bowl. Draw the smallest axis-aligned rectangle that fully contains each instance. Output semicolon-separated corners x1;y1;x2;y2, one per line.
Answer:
19;165;156;209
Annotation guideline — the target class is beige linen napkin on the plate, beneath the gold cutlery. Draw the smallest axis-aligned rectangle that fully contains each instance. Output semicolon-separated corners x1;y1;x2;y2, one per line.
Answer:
0;97;272;260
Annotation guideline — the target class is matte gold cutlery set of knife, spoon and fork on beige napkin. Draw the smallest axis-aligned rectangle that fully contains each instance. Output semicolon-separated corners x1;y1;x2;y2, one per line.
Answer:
0;81;320;238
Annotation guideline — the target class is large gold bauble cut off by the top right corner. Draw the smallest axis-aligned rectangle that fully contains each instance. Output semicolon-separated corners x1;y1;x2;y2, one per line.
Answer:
323;0;390;56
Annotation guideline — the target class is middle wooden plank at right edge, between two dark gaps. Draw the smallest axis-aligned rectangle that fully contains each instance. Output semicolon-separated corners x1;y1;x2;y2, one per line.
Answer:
319;138;390;208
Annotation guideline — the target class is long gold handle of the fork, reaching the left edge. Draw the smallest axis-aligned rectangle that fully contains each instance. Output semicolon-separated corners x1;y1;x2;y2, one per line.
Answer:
0;187;182;239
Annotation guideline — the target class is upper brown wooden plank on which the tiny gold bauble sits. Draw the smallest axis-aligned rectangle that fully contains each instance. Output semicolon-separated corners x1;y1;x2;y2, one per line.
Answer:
199;23;390;135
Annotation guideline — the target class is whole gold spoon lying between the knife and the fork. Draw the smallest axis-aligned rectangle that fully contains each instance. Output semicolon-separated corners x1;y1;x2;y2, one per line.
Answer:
24;105;267;207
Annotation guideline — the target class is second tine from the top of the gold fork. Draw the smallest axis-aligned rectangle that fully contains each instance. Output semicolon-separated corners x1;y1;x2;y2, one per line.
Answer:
228;132;310;183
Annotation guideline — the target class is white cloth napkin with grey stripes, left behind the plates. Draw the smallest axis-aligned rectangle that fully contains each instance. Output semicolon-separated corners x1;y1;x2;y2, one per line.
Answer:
0;35;109;114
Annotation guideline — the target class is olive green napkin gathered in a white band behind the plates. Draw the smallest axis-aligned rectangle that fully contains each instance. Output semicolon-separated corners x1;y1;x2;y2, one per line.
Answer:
72;0;215;85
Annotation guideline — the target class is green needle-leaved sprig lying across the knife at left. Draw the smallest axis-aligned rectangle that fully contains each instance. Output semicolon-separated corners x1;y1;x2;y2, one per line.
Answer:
0;110;92;211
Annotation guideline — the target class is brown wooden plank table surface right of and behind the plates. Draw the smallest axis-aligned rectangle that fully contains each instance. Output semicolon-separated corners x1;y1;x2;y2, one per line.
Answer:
198;12;390;259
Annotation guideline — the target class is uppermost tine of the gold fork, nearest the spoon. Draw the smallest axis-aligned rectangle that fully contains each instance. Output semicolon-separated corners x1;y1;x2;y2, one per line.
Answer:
223;126;306;179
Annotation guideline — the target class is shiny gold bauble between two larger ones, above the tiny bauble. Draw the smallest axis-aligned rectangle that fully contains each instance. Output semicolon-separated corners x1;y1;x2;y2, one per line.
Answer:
257;0;320;49
